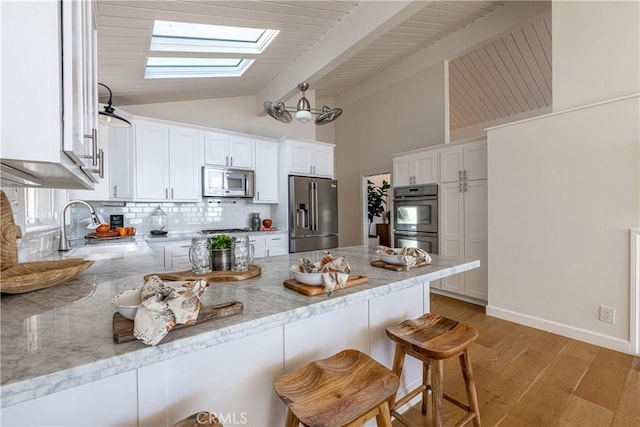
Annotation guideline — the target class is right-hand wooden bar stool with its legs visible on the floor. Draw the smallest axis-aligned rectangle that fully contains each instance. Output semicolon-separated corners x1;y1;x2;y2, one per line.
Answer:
386;313;480;427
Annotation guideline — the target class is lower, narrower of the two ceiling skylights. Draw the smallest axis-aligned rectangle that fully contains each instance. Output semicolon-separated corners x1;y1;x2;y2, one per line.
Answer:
144;57;254;79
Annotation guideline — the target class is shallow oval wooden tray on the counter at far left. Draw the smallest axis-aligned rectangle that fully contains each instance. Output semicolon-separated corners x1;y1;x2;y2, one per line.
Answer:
0;258;93;294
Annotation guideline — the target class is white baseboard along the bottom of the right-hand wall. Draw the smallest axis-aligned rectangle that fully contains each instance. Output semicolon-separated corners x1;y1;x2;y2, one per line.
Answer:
487;305;631;353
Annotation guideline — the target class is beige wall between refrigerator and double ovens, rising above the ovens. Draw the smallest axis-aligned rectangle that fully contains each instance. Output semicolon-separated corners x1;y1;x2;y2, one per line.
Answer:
335;63;448;246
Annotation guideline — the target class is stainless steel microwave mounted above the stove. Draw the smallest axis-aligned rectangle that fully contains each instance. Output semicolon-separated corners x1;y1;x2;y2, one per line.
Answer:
202;166;254;197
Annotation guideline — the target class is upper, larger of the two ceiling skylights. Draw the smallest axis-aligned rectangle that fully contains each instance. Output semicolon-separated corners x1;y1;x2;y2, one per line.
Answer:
150;21;279;54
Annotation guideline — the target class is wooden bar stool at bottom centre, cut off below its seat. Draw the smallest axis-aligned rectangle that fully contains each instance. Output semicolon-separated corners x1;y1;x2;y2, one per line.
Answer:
273;350;400;427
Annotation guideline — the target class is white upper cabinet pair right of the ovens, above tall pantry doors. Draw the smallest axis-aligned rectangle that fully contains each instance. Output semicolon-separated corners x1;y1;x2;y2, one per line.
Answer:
440;140;487;182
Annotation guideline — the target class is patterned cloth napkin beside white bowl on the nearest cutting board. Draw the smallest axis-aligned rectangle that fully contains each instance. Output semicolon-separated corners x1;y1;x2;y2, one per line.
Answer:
133;276;209;345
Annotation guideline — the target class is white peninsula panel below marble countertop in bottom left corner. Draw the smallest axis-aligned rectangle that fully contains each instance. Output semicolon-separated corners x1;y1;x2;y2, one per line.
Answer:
1;370;138;427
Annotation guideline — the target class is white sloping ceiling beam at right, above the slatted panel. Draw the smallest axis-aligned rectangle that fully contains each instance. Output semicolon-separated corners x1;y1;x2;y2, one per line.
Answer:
336;1;551;107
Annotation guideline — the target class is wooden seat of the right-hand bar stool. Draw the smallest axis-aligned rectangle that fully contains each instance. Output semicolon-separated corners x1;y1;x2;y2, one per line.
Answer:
386;313;478;359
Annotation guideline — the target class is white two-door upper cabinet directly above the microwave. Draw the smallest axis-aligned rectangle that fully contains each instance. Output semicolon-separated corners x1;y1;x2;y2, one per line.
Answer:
204;132;254;169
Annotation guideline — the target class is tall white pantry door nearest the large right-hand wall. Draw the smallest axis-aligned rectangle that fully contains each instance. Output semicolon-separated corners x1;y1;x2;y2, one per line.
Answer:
464;179;488;300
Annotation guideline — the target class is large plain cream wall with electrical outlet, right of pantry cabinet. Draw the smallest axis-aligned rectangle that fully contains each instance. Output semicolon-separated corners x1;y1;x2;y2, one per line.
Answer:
487;97;640;351
